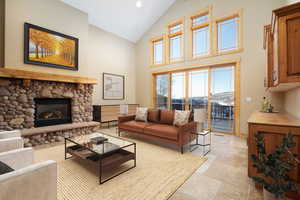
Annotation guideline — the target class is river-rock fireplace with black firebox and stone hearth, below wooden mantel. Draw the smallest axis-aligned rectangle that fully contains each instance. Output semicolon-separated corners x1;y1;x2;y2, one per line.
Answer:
0;71;99;146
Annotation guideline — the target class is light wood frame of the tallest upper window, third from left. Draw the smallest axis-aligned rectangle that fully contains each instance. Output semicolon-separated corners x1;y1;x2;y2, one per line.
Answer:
189;6;213;60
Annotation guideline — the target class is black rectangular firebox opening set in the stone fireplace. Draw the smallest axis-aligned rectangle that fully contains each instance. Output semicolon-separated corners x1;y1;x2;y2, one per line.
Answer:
34;98;72;127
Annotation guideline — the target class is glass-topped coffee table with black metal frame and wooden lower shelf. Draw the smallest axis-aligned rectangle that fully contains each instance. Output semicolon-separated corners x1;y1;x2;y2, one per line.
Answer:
65;132;136;184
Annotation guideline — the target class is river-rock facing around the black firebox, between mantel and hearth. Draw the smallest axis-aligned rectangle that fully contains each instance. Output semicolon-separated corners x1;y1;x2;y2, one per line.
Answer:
0;79;93;130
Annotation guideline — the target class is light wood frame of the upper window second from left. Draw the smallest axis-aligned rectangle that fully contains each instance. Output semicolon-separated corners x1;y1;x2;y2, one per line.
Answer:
166;17;185;64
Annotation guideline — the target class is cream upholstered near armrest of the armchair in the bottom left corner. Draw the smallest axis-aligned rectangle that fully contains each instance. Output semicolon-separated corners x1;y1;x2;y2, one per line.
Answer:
0;161;57;200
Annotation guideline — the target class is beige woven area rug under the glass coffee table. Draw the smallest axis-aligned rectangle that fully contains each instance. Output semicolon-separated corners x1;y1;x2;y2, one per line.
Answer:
35;130;206;200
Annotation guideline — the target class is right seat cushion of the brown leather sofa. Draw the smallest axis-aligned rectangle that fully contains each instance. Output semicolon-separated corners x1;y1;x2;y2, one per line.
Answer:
144;124;179;141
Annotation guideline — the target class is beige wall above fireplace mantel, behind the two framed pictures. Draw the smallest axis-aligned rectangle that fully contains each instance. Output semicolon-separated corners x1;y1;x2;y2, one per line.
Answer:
5;0;135;104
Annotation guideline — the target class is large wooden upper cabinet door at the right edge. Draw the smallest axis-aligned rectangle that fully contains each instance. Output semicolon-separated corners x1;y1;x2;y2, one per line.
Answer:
279;13;300;82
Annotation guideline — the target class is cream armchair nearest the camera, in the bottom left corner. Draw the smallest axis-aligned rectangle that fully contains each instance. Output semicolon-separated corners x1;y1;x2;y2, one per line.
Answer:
0;148;57;200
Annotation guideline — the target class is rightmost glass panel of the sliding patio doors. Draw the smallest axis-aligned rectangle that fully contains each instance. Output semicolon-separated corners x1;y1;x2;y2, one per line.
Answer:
210;66;235;133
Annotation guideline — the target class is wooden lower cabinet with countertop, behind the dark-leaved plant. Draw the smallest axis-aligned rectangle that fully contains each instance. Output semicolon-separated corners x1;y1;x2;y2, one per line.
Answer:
248;112;300;199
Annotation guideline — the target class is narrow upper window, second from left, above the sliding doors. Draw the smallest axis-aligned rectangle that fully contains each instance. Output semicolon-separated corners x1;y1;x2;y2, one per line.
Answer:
168;20;184;63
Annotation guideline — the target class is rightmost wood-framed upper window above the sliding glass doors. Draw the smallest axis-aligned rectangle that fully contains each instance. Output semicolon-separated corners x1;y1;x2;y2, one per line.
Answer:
216;10;241;54
